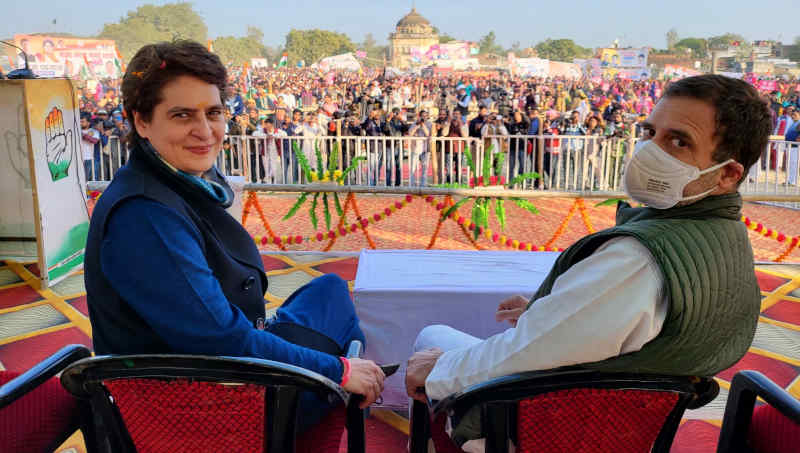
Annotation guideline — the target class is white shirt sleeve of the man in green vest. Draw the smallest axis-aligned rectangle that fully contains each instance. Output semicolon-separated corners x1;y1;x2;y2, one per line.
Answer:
424;237;668;400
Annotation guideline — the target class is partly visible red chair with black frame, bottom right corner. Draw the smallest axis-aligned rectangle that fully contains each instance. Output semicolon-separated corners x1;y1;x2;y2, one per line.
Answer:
717;370;800;453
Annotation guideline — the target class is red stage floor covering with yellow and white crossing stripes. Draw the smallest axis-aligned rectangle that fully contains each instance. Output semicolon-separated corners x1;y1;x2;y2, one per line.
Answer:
0;252;800;453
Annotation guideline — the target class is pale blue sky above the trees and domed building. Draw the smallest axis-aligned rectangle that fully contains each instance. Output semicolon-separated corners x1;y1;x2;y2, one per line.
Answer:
0;0;800;48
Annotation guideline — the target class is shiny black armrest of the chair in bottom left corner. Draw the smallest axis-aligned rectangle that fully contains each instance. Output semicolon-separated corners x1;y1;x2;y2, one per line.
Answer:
0;344;92;409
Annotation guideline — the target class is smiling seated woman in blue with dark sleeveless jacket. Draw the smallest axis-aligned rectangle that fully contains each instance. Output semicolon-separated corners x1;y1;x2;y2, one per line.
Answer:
84;41;384;428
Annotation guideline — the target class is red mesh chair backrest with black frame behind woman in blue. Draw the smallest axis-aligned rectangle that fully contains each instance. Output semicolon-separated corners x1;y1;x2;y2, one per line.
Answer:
61;355;349;453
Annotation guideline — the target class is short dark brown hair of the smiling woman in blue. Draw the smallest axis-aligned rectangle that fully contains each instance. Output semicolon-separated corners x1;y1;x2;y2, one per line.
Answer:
120;40;228;142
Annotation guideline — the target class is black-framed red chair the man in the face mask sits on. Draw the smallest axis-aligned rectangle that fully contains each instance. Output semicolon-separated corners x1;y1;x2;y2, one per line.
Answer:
410;371;719;453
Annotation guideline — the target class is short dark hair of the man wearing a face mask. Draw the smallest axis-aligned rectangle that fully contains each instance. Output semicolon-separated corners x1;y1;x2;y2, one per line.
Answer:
664;74;772;182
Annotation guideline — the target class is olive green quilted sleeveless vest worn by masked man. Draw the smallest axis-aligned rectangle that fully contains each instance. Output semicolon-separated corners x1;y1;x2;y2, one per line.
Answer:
529;193;761;376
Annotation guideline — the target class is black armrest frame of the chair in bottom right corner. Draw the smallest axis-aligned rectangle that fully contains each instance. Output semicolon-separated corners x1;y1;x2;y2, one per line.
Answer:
717;370;800;453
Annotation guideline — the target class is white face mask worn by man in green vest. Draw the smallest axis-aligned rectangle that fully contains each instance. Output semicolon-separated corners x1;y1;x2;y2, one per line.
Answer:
623;140;734;209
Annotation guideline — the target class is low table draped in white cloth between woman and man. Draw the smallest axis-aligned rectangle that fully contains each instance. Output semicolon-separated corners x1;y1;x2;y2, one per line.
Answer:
353;250;558;408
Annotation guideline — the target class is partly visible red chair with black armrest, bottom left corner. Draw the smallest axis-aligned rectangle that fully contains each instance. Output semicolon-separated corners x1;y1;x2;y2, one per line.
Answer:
0;345;91;453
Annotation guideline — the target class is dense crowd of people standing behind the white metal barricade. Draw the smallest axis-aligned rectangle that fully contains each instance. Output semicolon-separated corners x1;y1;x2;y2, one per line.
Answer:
79;68;800;185
